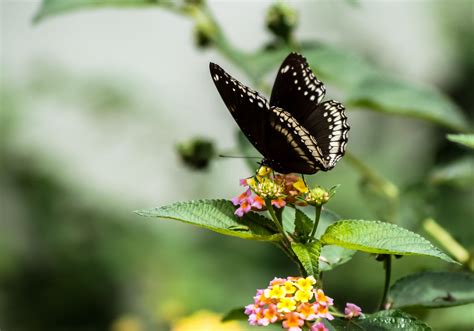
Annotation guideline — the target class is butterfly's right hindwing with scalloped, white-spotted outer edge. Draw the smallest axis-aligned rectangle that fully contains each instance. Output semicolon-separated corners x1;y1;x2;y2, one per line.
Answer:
302;100;350;171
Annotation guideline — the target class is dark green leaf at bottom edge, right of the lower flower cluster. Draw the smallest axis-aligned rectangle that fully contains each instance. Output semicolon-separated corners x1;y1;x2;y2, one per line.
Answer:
331;310;431;331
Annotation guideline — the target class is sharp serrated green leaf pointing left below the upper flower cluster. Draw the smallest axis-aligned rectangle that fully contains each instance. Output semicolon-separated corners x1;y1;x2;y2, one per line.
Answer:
136;200;281;241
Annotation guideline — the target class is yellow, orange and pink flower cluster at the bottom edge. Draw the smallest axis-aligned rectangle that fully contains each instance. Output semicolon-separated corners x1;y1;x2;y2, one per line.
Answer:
245;276;334;331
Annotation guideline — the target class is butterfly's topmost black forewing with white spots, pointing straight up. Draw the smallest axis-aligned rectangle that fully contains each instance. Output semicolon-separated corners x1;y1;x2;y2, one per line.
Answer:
270;53;326;123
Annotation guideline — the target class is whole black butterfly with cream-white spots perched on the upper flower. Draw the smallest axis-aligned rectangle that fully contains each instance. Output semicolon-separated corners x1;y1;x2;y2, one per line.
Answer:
209;53;349;174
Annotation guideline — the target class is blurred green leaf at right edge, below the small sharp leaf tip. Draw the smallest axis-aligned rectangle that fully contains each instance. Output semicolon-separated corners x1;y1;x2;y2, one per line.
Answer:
430;156;474;188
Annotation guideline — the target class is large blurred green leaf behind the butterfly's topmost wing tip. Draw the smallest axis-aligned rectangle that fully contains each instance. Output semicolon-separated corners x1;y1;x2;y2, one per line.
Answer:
245;43;469;131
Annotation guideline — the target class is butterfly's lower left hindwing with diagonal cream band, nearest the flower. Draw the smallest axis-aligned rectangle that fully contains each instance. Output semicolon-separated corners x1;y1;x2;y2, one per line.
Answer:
264;107;326;174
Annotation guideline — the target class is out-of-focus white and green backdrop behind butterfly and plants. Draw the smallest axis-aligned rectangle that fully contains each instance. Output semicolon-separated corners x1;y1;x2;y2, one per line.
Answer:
0;0;474;331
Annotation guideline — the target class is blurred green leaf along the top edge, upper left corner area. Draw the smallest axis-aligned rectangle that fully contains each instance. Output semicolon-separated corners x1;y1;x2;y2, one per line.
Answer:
33;0;165;23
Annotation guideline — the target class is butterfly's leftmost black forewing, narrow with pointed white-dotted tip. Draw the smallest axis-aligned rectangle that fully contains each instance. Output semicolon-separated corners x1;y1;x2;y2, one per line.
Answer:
209;63;270;156
